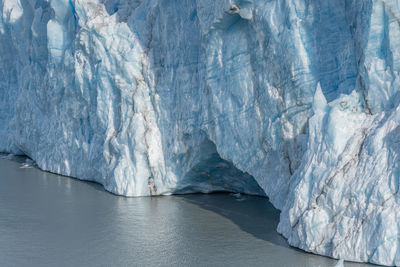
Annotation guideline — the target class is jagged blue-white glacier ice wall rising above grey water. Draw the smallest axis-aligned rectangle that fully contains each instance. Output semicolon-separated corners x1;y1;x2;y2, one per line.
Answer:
0;0;400;265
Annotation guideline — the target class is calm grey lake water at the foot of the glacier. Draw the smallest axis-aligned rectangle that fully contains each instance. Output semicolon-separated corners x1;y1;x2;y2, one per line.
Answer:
0;159;372;267
